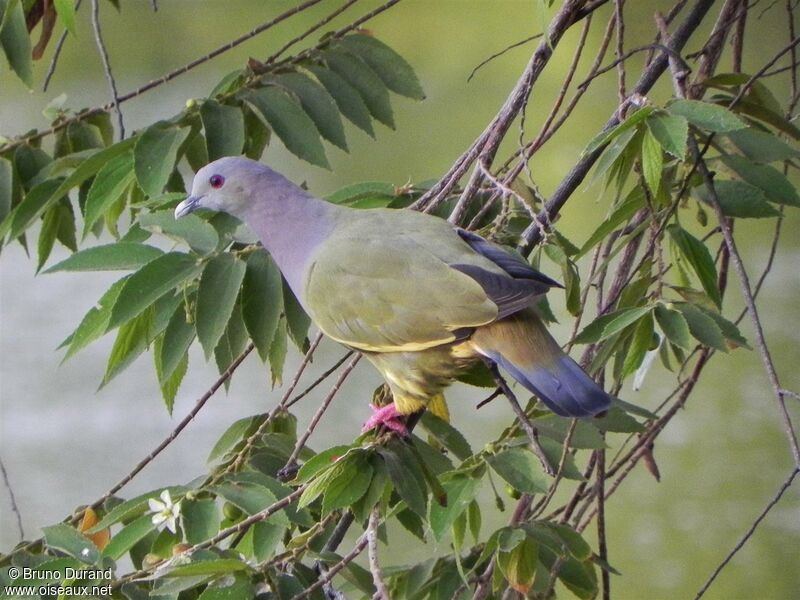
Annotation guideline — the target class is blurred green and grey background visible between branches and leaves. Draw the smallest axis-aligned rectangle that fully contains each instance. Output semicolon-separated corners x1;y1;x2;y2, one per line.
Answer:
0;0;800;599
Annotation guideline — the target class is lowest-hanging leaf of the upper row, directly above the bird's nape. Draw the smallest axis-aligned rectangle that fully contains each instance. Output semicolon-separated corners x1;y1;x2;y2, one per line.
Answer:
244;86;330;169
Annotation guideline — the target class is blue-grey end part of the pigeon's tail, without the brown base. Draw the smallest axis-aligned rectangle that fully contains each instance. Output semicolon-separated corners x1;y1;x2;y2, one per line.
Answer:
487;351;611;417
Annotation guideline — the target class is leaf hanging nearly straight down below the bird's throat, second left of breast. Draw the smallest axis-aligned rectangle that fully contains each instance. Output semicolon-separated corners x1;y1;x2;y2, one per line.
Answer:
195;253;245;358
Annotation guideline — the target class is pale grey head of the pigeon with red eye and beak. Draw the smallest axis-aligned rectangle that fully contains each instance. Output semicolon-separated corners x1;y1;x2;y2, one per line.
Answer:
175;156;277;219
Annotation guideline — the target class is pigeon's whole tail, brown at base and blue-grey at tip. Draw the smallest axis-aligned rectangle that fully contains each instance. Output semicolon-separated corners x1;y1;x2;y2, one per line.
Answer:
470;309;611;417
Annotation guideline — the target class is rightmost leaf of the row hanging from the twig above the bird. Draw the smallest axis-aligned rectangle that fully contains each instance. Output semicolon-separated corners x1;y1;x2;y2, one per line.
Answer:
339;33;425;100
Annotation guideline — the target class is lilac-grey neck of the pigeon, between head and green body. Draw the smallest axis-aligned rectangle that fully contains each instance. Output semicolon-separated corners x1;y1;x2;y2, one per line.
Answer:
236;184;343;301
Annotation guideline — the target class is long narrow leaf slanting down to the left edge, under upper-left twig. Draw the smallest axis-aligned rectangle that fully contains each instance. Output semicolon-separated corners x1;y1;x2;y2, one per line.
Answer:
0;138;136;239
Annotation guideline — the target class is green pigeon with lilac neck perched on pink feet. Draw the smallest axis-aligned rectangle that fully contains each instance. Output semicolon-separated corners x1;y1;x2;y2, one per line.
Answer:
175;156;612;434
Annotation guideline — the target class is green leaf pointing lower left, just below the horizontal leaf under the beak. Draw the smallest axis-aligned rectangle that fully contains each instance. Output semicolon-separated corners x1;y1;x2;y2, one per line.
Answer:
106;252;200;331
